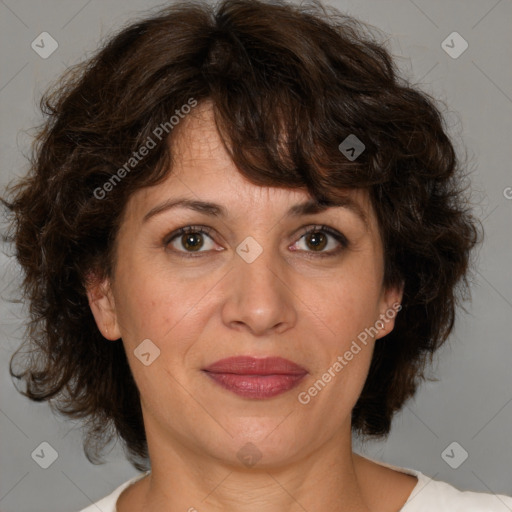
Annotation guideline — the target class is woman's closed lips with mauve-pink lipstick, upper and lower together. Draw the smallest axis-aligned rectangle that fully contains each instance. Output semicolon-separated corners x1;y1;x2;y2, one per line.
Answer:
203;356;308;400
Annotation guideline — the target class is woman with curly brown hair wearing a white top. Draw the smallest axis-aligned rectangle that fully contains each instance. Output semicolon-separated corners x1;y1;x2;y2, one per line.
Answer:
4;0;512;512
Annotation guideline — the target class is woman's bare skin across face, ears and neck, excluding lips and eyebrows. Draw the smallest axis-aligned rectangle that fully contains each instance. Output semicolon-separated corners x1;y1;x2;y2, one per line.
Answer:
88;103;417;512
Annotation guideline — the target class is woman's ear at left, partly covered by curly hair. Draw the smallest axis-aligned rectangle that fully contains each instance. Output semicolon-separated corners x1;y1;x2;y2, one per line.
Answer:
85;274;121;341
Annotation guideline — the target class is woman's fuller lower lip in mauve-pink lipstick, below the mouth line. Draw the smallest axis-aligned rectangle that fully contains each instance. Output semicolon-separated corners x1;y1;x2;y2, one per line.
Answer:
205;372;306;400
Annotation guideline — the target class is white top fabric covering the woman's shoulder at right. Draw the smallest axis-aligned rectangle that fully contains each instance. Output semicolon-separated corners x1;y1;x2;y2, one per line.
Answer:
400;471;512;512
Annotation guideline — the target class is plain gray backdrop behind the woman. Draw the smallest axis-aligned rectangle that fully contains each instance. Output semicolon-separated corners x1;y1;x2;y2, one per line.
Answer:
0;0;512;512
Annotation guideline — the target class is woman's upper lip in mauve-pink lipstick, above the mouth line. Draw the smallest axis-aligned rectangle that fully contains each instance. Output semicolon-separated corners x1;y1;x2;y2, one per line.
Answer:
204;356;307;375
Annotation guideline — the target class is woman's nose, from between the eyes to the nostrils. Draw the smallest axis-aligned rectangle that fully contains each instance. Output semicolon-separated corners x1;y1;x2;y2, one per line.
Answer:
222;238;298;336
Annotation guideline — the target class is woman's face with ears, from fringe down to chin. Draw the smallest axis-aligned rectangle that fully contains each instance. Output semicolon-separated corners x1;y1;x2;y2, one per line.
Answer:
89;102;401;467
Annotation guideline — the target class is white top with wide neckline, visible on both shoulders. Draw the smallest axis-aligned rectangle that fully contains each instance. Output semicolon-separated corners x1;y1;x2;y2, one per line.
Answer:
76;457;512;512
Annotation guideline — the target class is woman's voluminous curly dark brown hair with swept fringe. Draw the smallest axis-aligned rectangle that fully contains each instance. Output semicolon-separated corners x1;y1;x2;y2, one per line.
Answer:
3;0;482;470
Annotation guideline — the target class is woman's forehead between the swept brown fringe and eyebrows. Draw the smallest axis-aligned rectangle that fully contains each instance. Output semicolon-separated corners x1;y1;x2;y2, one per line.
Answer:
126;102;375;236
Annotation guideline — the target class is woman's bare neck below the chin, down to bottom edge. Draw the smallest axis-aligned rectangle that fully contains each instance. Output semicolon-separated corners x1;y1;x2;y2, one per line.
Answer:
136;420;369;512
